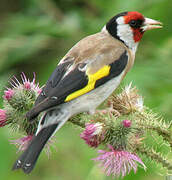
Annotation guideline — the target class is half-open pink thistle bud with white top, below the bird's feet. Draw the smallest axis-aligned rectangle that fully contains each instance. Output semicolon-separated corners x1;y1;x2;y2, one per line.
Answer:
80;123;104;148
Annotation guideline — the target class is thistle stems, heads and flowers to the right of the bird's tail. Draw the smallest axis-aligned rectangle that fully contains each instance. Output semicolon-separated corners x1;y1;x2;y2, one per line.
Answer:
74;83;172;177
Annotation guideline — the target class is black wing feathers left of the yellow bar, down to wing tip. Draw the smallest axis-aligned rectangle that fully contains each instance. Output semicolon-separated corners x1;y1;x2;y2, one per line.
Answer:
26;60;88;120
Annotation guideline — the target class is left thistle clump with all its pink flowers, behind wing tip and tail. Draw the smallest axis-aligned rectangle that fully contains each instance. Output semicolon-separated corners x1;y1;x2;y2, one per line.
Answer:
0;73;55;156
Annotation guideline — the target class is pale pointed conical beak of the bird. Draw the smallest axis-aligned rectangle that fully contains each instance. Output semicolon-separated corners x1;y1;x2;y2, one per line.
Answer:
141;18;162;31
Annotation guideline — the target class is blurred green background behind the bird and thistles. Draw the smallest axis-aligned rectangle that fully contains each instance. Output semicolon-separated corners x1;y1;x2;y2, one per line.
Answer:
0;0;172;180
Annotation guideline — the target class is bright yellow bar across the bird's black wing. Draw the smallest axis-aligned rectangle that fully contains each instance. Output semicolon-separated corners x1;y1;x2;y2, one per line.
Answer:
65;65;110;102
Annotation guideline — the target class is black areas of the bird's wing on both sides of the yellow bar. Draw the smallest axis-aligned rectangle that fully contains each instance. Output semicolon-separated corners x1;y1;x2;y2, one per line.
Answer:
26;51;128;120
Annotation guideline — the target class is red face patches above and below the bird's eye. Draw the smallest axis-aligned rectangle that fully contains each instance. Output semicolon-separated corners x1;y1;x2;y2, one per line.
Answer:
124;11;144;42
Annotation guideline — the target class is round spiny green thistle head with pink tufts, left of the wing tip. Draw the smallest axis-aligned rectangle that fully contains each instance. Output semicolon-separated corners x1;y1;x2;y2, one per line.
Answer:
1;73;41;135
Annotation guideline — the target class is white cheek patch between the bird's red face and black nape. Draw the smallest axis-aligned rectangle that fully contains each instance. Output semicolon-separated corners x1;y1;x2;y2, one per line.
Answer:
116;17;138;52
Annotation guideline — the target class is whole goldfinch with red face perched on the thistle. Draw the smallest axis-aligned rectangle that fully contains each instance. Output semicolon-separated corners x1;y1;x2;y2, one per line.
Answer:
12;11;162;174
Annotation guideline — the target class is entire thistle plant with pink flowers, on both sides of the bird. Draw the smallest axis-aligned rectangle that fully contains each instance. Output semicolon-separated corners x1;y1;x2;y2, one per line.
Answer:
0;73;172;178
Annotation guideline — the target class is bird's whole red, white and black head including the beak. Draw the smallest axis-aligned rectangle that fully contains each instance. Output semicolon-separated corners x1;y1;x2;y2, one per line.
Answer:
104;11;162;52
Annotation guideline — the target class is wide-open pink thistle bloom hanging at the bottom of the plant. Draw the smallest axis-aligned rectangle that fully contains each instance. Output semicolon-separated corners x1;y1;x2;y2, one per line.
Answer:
93;145;146;177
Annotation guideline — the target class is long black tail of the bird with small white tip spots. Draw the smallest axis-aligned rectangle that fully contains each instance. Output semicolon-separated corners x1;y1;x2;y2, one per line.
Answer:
12;124;58;174
